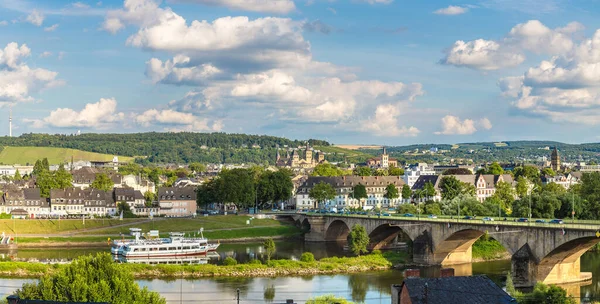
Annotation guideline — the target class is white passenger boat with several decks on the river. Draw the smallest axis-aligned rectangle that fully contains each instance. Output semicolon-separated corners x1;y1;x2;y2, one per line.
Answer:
120;232;219;258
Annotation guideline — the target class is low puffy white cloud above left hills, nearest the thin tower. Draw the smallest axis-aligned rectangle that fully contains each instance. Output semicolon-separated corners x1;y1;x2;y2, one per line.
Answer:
25;98;125;129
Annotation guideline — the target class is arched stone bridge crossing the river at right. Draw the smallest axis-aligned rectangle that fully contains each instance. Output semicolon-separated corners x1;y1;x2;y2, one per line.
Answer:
292;214;600;287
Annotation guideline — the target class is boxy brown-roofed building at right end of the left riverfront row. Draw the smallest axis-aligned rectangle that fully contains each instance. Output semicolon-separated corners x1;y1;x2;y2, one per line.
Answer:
158;187;197;217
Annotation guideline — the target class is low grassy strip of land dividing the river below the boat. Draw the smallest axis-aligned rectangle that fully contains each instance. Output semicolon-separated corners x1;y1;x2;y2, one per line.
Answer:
0;252;407;278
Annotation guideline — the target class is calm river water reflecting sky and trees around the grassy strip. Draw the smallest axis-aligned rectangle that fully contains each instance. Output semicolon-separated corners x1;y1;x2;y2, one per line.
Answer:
0;240;600;304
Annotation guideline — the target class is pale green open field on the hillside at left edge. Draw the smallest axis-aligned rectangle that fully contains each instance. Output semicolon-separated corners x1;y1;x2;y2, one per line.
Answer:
0;147;133;165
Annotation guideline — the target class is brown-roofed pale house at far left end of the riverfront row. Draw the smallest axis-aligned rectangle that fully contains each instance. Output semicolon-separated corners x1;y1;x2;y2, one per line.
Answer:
0;188;50;218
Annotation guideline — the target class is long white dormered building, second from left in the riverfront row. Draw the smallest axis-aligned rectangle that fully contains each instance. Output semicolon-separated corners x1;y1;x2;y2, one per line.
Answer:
50;188;117;216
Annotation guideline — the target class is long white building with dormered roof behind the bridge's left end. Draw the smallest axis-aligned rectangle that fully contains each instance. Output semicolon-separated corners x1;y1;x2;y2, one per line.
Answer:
295;176;404;210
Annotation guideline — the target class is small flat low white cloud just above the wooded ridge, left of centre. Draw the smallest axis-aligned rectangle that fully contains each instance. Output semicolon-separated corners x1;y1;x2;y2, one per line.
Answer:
135;109;223;132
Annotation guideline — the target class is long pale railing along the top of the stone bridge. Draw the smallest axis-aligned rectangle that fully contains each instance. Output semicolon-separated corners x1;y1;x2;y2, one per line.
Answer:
300;213;600;231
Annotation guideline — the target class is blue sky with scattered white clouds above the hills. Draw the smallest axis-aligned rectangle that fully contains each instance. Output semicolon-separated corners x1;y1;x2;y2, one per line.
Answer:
0;0;600;145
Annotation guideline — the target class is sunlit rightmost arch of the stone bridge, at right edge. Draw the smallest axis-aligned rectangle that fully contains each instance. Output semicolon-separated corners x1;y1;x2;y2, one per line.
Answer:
536;236;600;284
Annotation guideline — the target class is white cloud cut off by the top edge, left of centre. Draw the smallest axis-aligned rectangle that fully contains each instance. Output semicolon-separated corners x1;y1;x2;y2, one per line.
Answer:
170;0;296;14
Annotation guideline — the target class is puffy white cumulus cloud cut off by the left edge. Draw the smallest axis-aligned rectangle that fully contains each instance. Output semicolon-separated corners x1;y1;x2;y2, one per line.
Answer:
0;42;63;103
